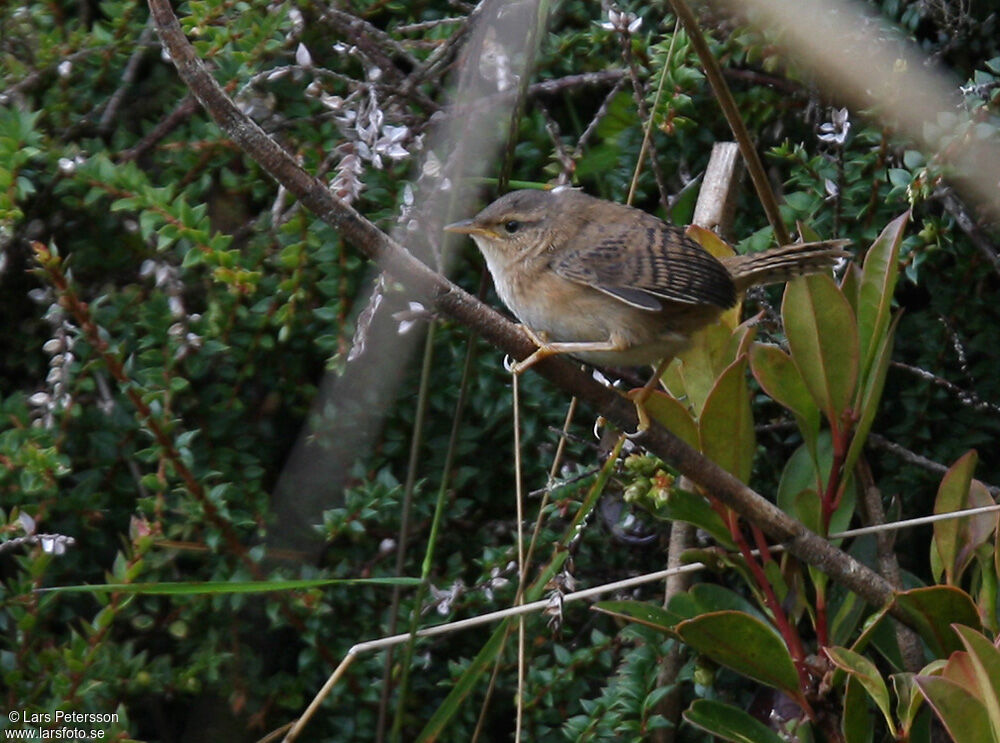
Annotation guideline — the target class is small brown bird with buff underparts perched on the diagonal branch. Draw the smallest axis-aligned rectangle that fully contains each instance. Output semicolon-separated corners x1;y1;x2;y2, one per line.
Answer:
445;187;848;372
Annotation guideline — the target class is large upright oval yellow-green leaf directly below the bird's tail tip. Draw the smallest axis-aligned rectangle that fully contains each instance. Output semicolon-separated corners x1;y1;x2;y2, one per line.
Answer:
781;274;859;424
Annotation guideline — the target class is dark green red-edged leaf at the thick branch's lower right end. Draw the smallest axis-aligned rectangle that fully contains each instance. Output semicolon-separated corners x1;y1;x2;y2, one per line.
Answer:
893;586;982;658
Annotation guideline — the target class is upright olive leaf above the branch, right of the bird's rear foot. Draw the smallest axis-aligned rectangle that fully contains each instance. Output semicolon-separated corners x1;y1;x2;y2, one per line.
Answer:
698;356;757;482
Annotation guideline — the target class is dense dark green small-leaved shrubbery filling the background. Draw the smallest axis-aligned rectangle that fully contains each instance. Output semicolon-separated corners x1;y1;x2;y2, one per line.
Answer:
0;0;1000;741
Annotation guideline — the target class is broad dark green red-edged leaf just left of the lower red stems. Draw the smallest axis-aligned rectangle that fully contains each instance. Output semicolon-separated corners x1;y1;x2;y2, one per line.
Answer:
676;611;801;699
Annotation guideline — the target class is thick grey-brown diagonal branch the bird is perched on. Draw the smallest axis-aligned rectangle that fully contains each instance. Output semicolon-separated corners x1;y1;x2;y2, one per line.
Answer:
149;0;908;621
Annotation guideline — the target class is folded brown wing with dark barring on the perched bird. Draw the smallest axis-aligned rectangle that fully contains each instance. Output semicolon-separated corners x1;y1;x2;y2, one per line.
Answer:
552;217;736;312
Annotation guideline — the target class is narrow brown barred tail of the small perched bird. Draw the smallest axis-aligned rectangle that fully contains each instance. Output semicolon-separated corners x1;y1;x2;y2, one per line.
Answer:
723;240;851;292
